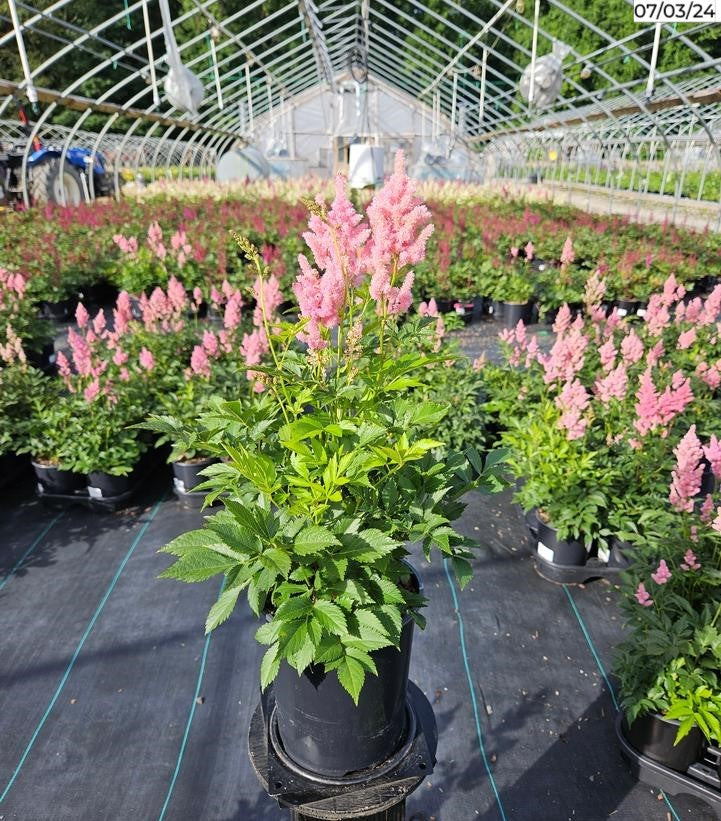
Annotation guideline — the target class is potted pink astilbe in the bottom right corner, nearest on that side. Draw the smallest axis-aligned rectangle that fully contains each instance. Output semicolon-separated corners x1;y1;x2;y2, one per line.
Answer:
615;426;721;772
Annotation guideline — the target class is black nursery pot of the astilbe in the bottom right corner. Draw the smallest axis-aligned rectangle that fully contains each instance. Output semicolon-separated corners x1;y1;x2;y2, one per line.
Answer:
623;713;705;773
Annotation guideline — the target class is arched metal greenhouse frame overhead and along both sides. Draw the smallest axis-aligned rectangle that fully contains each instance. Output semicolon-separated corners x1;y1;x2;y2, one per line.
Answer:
0;0;721;224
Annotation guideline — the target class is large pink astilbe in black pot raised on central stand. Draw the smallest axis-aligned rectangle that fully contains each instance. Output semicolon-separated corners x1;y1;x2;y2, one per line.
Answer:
150;154;502;776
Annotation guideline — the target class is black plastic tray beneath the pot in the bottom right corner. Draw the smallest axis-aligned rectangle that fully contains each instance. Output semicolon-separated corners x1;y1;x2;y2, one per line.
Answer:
616;713;721;818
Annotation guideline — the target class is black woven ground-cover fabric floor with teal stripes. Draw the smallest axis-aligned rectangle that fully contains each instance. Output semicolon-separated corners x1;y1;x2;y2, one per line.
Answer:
0;464;715;821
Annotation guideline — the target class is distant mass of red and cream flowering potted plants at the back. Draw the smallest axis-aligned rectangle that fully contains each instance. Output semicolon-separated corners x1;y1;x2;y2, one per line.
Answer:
0;181;721;317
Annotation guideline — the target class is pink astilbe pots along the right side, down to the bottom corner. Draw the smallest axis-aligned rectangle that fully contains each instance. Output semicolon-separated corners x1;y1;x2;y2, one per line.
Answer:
484;274;721;772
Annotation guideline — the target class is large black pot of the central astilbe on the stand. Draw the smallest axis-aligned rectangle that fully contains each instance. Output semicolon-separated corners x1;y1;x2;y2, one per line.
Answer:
274;572;422;778
